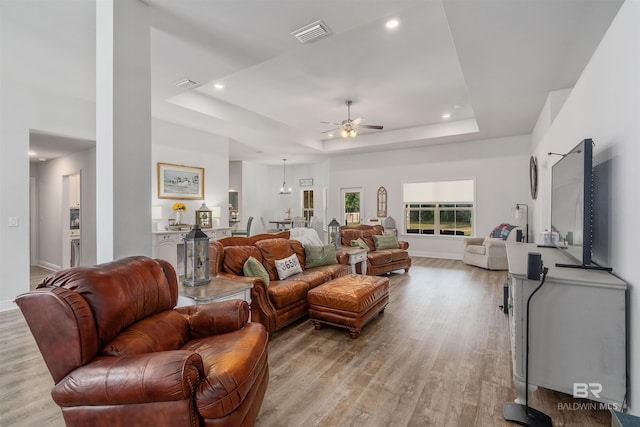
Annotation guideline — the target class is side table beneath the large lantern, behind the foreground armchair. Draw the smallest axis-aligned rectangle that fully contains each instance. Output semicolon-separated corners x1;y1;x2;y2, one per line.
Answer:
178;277;251;307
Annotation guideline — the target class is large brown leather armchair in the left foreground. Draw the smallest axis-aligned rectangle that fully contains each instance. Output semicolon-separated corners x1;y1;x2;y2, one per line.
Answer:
16;257;269;427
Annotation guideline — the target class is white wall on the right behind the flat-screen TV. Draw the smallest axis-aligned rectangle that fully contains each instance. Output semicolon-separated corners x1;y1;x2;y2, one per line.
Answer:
533;0;640;415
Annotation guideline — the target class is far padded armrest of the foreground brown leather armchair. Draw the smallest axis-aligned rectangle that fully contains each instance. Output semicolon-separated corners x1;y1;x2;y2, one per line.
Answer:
176;300;249;338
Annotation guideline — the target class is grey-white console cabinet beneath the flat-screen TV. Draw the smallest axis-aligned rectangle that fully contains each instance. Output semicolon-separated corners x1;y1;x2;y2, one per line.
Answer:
507;243;627;409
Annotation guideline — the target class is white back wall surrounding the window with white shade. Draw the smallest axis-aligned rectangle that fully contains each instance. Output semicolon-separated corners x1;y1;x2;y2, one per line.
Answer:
328;135;531;259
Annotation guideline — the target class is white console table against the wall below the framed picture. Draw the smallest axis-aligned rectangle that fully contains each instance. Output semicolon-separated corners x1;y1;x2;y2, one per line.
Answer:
151;227;231;276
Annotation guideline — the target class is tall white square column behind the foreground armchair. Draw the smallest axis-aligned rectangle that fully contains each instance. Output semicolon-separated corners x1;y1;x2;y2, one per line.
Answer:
96;0;152;263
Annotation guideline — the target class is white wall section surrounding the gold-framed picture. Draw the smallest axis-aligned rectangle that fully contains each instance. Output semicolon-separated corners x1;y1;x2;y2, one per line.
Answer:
149;119;229;231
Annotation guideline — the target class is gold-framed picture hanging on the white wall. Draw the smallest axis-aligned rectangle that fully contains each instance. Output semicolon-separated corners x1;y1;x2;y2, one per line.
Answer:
158;162;204;200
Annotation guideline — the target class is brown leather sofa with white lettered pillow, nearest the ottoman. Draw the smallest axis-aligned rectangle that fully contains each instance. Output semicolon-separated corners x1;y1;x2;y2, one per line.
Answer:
209;231;351;334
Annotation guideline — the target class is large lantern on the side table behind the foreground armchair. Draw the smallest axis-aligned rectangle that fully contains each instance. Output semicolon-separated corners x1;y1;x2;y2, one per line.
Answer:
182;224;210;286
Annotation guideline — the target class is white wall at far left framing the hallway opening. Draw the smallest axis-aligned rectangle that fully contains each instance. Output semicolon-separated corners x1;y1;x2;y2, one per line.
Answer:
0;77;95;310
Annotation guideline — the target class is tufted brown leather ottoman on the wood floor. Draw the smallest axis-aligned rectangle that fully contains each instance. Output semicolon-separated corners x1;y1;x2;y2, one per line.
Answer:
307;274;389;339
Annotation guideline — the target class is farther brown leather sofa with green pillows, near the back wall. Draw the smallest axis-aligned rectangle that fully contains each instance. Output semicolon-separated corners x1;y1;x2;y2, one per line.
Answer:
340;225;411;276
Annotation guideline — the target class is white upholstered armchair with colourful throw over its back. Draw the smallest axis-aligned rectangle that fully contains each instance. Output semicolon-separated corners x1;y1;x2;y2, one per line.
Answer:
462;224;522;270
